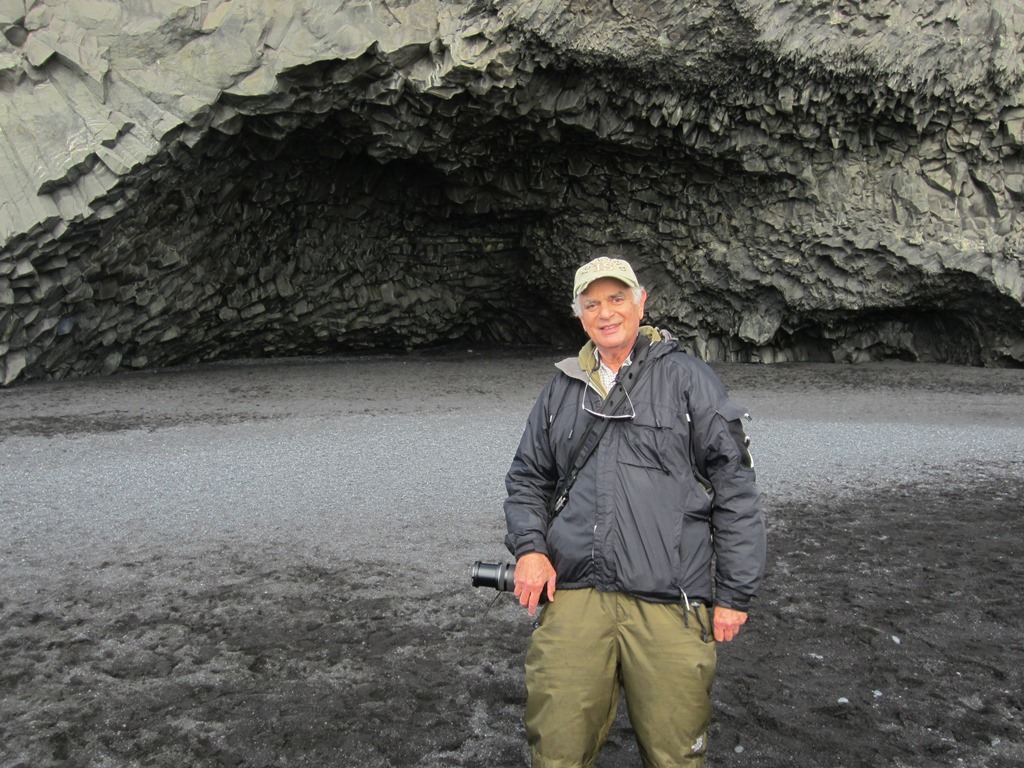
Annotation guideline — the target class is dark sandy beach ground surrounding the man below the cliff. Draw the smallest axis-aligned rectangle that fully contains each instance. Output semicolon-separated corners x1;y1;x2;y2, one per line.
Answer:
0;351;1024;768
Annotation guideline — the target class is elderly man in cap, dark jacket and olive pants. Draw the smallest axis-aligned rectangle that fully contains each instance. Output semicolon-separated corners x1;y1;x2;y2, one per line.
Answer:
505;257;765;768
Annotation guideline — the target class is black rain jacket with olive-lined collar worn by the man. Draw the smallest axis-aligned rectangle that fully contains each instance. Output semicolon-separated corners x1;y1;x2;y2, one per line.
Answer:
505;327;766;610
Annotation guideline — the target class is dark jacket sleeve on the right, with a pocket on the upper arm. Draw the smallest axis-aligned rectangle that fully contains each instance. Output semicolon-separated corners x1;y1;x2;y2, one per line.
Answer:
690;368;767;610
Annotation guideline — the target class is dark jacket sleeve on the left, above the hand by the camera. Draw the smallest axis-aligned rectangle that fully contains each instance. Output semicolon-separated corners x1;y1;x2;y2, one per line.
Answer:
505;384;558;559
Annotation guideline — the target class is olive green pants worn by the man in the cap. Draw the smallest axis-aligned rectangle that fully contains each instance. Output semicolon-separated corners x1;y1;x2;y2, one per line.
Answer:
526;589;717;768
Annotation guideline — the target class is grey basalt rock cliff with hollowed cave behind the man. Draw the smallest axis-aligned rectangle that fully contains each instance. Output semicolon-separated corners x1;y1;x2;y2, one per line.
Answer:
0;0;1024;384
